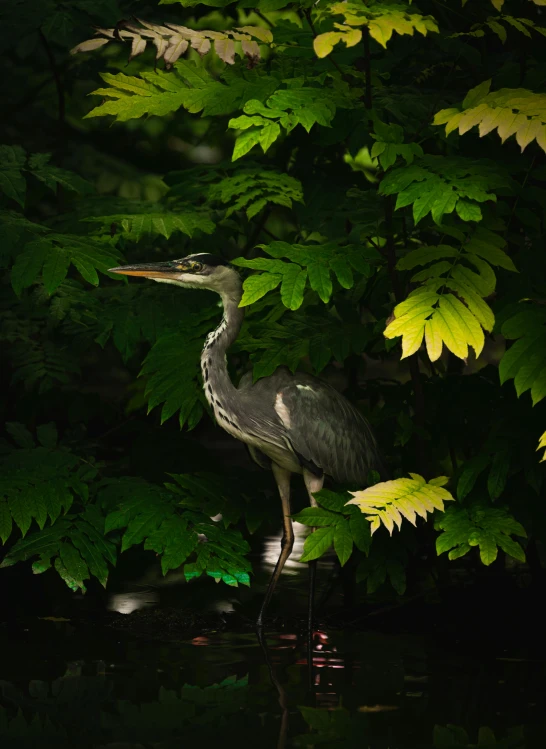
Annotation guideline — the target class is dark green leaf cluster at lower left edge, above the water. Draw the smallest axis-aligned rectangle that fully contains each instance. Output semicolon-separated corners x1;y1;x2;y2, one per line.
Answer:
0;423;116;592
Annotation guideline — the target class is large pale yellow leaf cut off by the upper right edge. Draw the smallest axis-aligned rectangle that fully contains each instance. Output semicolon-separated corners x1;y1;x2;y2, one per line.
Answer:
434;79;546;151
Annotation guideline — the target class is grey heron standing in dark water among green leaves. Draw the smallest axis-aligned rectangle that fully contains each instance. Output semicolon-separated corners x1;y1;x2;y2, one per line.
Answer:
110;253;382;627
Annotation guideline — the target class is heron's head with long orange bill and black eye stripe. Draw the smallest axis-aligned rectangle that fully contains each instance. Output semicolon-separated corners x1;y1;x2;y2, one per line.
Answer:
110;252;241;296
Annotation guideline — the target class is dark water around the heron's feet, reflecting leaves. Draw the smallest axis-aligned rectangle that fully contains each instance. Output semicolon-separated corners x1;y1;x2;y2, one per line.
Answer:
0;528;546;749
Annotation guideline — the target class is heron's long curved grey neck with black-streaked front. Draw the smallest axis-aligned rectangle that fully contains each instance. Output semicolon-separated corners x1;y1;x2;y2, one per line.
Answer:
201;291;244;414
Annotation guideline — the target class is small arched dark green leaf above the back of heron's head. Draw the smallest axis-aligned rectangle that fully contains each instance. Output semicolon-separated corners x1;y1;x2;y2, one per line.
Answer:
209;169;303;219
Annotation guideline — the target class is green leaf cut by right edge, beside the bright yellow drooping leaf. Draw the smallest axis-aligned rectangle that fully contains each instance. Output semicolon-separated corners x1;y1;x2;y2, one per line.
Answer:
499;304;546;406
